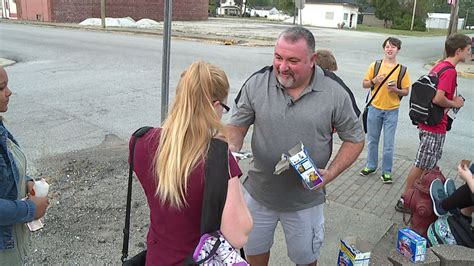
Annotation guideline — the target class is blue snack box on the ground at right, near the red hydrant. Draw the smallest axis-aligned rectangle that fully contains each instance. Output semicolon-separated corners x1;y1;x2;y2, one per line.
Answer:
397;228;426;263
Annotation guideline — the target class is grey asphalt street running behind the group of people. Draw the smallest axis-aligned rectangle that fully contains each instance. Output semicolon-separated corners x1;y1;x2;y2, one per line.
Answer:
0;22;474;171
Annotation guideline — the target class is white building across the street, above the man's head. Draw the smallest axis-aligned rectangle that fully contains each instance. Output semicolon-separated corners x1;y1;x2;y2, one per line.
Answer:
297;0;359;29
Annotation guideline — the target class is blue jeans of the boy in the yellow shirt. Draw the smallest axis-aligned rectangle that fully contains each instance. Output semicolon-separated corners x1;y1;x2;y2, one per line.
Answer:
367;106;398;174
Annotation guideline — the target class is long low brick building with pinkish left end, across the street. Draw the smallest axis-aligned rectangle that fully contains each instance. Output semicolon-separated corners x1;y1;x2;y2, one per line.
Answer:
16;0;209;23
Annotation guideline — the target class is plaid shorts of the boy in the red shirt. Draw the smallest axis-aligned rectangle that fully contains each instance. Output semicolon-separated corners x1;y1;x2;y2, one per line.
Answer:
415;129;446;169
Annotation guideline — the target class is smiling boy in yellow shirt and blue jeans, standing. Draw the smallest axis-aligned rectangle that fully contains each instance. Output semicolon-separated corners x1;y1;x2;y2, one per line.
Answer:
360;37;411;184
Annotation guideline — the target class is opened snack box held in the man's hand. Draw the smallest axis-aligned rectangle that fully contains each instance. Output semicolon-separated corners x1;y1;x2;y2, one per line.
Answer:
288;143;323;190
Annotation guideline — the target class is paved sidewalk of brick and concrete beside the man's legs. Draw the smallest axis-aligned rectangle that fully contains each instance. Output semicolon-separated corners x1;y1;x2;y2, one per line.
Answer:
240;140;461;265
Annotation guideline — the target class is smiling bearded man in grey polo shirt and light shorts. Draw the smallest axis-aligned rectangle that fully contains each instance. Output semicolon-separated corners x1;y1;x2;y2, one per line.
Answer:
228;27;364;265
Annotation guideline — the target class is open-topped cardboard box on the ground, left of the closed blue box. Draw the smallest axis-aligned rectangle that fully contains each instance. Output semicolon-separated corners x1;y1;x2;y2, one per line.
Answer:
337;236;371;266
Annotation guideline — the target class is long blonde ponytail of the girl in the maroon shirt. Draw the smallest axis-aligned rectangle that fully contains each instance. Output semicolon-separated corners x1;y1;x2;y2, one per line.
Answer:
153;61;229;209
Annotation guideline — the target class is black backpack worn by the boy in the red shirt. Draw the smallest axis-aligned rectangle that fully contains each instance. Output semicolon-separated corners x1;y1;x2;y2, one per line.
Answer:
408;66;454;126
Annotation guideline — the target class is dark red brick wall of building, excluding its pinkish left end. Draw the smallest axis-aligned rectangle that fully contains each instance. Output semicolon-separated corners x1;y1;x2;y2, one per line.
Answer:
45;0;209;23
